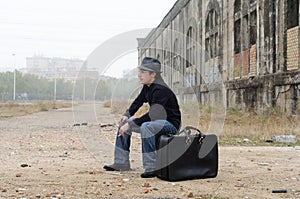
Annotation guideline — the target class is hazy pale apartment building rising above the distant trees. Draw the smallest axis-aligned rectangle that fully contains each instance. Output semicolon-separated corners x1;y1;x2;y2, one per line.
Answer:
26;56;99;81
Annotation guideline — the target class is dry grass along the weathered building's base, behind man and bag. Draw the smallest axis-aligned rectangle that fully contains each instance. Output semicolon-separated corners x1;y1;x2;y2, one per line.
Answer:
111;102;300;145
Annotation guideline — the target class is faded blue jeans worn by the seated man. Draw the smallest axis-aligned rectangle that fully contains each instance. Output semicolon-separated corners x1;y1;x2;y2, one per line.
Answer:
114;119;178;170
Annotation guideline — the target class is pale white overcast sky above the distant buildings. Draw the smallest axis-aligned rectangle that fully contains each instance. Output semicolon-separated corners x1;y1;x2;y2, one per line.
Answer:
0;0;176;76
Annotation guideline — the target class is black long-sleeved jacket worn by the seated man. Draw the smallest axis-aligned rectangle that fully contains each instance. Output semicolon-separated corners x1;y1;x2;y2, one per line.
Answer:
124;79;181;130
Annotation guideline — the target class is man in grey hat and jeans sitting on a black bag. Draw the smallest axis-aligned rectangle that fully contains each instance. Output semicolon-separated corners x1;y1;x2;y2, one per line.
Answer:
103;57;181;178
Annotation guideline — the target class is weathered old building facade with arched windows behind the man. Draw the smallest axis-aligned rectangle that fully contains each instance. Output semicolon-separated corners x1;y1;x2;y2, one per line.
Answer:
138;0;300;114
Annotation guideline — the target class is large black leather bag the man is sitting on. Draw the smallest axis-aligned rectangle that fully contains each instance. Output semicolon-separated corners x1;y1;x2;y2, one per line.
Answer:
156;126;218;181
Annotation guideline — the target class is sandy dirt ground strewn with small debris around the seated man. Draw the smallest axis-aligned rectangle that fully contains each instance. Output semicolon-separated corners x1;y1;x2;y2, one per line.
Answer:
0;104;300;199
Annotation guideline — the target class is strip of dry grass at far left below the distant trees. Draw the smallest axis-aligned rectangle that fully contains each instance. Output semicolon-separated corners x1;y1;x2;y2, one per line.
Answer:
0;101;72;119
